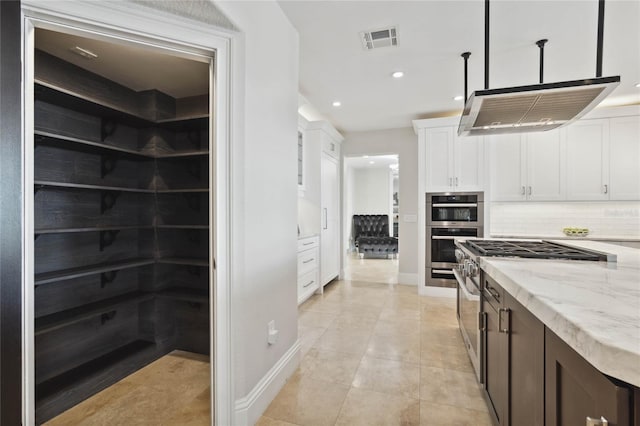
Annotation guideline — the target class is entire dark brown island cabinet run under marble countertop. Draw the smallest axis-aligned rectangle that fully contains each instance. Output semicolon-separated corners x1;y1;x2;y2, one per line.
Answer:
482;273;640;426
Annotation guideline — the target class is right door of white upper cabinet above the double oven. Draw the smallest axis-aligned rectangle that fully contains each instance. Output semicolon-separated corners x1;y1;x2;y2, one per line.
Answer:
453;133;484;191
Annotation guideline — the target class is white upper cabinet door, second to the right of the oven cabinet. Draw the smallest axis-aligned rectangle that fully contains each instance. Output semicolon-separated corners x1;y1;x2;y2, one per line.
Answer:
525;130;566;201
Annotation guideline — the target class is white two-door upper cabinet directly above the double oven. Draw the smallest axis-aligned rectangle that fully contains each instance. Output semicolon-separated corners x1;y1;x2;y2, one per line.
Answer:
424;126;484;192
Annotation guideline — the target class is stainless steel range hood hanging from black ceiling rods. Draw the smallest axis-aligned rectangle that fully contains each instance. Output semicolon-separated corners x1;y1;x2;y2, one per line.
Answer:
458;76;620;136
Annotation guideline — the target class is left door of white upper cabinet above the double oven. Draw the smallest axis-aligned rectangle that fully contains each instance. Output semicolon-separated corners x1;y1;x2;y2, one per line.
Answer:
424;127;454;192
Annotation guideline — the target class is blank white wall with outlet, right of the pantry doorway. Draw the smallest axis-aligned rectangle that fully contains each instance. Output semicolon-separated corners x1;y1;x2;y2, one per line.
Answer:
215;1;298;421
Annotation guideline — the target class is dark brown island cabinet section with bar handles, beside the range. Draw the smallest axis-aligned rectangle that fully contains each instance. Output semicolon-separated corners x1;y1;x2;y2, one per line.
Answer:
482;274;544;426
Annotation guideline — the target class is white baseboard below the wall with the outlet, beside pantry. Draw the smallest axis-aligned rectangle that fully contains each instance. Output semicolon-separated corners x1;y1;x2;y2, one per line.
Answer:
234;340;300;426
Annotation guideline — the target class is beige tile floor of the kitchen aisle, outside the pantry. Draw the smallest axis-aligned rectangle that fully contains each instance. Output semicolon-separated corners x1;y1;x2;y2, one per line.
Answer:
257;258;491;426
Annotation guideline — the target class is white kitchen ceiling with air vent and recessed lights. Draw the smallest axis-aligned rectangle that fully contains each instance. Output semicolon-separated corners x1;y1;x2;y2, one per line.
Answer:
280;0;640;132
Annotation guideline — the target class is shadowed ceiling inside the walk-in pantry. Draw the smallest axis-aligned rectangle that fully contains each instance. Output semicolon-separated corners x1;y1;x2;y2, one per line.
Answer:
35;28;209;98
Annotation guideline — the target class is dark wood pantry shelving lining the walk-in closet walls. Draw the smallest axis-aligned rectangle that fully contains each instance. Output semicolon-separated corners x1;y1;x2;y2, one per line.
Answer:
34;51;210;424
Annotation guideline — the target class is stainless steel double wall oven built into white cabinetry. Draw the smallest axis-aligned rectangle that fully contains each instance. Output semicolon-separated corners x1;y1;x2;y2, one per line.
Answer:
425;192;484;288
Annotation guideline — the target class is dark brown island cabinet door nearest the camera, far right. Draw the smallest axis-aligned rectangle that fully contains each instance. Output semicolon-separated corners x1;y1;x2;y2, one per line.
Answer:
545;329;640;426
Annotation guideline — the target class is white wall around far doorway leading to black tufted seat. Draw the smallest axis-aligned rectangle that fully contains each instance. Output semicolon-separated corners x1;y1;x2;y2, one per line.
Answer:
342;127;422;284
